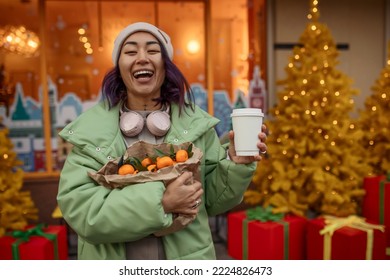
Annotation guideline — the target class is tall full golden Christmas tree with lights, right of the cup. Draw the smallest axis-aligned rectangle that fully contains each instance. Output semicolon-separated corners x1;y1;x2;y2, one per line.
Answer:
245;1;370;216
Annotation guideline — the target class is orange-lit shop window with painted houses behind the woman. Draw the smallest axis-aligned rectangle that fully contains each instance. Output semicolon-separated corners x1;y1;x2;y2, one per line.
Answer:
0;0;265;175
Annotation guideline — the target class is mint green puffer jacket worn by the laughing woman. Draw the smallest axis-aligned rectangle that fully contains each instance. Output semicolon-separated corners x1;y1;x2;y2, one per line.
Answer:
57;102;256;260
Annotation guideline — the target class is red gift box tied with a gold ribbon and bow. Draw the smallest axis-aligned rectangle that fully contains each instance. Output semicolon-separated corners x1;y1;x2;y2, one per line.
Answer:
306;216;386;260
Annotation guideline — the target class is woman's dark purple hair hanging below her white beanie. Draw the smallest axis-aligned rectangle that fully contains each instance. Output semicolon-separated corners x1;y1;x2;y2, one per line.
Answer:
102;40;194;114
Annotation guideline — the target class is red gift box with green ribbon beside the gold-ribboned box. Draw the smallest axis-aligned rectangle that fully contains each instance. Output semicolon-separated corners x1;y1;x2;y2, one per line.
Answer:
227;211;306;260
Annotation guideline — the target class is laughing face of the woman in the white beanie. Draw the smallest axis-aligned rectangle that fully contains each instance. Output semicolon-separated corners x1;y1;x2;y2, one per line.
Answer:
118;32;165;99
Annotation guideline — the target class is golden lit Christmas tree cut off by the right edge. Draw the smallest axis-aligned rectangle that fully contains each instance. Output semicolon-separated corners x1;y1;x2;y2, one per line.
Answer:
359;42;390;175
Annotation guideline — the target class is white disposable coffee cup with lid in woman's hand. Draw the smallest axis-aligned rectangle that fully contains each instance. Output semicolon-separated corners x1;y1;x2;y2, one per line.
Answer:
230;108;264;156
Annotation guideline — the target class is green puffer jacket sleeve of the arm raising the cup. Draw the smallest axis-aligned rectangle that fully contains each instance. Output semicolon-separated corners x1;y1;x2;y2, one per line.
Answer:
203;129;257;216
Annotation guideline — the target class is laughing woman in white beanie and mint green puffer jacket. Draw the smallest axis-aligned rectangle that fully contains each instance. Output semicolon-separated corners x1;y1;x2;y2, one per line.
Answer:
58;22;266;259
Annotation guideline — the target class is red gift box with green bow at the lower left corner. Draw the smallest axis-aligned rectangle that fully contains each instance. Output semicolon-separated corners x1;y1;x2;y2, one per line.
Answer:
0;225;68;260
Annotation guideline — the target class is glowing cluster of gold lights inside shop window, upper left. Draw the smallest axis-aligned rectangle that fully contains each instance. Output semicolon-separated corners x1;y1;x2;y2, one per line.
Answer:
0;25;40;57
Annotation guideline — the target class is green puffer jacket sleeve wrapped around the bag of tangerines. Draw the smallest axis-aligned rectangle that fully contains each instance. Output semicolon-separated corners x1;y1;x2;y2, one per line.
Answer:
57;147;172;244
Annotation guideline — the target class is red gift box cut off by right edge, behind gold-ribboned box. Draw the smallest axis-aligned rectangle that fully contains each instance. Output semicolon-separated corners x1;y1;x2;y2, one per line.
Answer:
362;173;390;259
